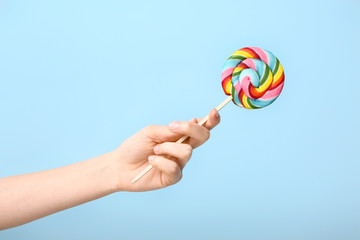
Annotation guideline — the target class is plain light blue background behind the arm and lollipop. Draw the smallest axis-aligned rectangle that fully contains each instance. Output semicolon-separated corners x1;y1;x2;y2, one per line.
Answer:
0;0;360;240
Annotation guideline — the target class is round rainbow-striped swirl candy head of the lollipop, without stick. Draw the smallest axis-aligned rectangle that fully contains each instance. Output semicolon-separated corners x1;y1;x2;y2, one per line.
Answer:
221;47;285;109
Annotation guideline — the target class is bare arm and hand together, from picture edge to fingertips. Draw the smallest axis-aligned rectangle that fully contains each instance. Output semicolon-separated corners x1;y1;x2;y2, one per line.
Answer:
0;109;220;230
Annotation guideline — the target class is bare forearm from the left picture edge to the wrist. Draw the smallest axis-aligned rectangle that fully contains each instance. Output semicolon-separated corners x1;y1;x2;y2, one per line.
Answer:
0;152;117;230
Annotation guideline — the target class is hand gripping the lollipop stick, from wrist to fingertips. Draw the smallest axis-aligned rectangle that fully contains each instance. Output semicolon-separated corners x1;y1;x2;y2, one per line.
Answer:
113;108;220;192
